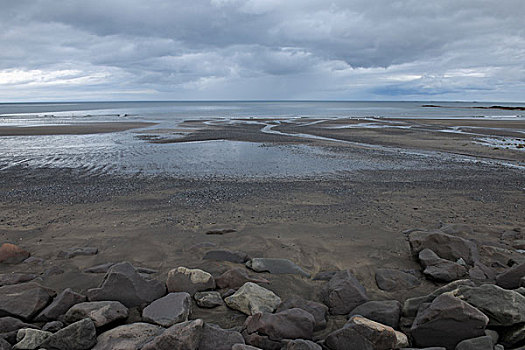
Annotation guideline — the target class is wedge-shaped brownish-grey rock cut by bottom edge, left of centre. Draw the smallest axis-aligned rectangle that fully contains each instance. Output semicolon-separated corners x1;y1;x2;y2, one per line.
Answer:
141;319;204;350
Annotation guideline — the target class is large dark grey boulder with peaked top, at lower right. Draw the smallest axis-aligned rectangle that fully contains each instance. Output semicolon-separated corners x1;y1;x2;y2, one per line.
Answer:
411;294;489;349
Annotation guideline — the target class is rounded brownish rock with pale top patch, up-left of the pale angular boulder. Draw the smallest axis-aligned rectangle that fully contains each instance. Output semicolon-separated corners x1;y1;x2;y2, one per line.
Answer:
166;266;215;295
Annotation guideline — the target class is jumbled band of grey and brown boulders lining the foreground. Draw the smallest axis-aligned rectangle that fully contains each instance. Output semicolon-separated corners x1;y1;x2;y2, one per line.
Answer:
0;229;525;350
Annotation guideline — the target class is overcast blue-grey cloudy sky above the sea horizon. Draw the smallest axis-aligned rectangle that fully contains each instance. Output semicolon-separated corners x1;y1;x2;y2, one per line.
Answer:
0;0;525;102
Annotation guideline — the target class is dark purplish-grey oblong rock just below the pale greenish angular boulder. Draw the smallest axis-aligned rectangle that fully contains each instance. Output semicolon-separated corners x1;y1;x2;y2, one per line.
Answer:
244;308;315;340
